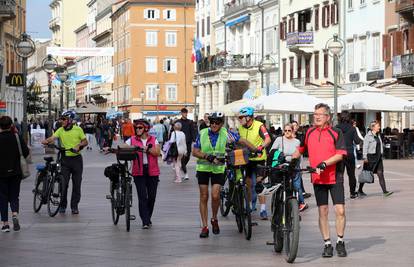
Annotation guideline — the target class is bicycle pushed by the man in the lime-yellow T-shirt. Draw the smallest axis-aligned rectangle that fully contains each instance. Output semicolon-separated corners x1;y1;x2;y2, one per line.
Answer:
32;145;72;217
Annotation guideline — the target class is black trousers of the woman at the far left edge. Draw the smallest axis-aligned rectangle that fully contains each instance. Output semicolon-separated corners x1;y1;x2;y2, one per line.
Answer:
0;176;21;222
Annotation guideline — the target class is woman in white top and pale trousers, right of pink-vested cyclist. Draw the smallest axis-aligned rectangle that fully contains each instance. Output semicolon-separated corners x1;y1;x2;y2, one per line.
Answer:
168;122;187;183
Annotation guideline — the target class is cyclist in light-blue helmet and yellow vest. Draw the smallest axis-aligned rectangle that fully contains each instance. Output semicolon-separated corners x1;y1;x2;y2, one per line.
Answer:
239;107;272;220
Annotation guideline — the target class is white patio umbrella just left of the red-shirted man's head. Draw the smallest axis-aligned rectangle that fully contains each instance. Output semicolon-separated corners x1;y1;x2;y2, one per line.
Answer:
253;85;324;113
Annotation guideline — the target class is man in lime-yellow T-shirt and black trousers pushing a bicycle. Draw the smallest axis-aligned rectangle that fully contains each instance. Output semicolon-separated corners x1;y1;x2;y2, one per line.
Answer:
42;110;88;214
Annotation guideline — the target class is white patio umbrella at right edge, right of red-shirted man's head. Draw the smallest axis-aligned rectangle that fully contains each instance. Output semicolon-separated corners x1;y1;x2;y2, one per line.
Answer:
331;86;414;112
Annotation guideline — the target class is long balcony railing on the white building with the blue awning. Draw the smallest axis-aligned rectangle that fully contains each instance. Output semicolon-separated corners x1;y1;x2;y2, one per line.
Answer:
197;54;260;72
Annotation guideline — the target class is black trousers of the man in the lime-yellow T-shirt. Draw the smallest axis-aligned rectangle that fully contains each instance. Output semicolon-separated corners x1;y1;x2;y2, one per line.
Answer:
61;155;83;209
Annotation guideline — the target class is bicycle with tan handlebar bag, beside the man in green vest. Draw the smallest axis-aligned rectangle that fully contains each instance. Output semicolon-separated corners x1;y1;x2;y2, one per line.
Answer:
218;148;256;240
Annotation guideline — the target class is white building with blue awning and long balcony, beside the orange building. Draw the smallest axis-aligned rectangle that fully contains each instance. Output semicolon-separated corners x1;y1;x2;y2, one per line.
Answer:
193;0;279;119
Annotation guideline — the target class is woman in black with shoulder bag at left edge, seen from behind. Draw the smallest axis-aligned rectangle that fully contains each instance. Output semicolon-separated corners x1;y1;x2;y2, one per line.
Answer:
0;116;29;233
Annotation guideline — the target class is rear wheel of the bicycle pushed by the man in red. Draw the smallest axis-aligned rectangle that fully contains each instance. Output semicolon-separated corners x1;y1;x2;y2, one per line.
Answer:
271;190;283;253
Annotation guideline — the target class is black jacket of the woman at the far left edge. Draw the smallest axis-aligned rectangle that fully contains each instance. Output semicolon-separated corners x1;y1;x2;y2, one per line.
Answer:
0;131;29;178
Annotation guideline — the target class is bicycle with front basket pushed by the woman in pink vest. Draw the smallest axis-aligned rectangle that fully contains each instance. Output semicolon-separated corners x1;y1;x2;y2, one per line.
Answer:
105;146;150;232
